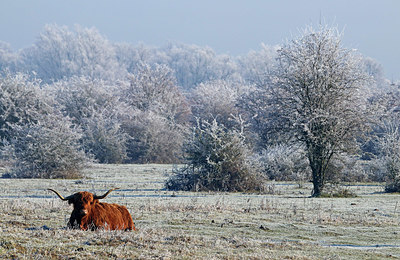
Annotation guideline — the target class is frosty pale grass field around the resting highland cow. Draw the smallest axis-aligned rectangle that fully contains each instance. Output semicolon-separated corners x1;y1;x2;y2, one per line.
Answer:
0;165;400;259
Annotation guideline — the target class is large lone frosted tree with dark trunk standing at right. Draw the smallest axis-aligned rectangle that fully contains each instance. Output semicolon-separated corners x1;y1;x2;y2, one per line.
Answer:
270;27;368;196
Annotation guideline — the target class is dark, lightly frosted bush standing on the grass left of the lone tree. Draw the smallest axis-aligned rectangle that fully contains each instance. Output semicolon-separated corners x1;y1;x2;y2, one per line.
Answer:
166;120;266;191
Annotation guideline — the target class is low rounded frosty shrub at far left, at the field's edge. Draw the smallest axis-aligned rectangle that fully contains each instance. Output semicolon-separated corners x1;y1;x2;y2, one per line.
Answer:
2;116;88;178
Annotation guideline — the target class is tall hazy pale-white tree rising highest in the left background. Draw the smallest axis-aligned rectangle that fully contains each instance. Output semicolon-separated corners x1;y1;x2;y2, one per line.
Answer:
22;25;124;83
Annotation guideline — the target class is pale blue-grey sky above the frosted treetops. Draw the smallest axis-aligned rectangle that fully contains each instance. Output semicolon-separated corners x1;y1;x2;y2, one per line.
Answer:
0;0;400;80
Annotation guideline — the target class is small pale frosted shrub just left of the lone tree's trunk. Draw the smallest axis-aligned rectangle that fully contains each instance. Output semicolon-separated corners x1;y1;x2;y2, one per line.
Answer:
259;144;311;181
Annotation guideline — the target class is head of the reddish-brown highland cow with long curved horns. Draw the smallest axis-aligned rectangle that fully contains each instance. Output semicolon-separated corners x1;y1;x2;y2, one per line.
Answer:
48;188;118;217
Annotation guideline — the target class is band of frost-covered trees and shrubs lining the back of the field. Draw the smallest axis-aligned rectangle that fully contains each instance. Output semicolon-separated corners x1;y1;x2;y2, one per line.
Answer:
0;25;400;193
